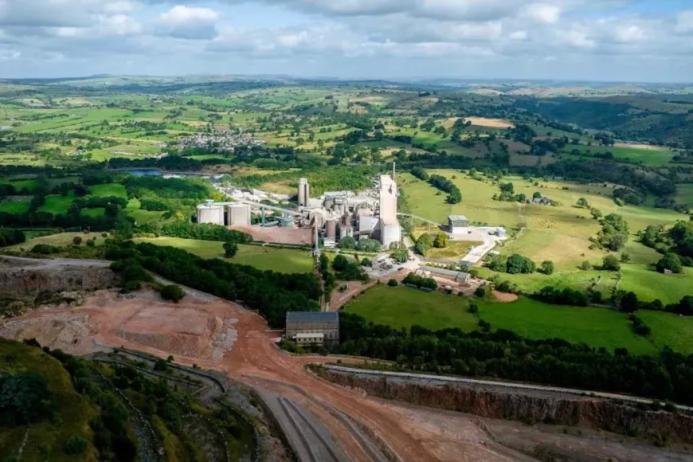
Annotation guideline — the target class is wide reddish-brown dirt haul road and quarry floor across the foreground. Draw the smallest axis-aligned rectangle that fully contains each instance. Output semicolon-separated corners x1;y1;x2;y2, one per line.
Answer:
0;290;522;461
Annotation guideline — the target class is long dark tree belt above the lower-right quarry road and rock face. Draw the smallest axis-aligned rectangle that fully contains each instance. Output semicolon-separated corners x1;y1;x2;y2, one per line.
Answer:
335;313;693;404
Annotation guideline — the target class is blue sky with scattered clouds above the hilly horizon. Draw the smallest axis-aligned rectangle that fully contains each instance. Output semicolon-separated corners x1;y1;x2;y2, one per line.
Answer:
0;0;693;82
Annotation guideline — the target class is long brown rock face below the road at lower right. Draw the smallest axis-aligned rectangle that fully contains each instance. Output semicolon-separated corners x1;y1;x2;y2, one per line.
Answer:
315;368;693;443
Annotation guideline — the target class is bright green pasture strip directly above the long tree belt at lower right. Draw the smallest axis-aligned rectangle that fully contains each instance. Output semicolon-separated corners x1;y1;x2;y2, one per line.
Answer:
344;285;693;354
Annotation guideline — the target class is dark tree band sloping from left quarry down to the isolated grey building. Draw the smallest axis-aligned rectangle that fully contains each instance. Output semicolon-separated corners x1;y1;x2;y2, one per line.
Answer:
106;242;322;327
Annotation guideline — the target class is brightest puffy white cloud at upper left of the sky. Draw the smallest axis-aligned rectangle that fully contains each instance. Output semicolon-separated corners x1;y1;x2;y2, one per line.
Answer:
159;5;220;39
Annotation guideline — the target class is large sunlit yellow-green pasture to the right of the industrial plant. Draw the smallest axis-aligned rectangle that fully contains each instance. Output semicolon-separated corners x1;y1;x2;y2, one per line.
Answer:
399;170;693;303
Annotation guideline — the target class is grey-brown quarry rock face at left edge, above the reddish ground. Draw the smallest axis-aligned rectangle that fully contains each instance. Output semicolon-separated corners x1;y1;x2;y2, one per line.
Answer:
0;257;116;298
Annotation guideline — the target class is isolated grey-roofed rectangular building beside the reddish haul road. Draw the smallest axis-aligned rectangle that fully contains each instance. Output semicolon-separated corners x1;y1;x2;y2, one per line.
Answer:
285;311;339;345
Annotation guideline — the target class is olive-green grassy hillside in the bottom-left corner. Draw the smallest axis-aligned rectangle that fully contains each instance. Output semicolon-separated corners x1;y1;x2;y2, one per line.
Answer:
0;338;96;462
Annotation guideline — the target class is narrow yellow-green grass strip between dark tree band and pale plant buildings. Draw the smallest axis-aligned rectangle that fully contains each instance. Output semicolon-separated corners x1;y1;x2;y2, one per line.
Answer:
134;237;313;273
